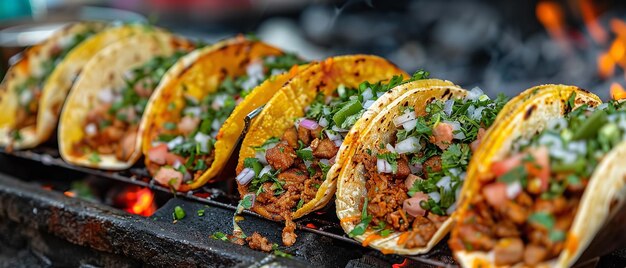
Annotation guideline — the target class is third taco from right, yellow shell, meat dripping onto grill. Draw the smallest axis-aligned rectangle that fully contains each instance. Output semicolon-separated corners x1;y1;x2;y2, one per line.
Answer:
237;55;406;245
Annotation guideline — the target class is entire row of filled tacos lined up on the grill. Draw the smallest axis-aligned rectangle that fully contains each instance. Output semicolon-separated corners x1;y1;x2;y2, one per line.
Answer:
0;22;626;266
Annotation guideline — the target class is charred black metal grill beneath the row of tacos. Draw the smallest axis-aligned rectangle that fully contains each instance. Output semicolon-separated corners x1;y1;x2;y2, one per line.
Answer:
0;145;626;267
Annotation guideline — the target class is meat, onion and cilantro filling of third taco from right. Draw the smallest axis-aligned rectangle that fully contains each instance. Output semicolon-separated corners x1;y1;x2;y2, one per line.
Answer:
237;72;428;246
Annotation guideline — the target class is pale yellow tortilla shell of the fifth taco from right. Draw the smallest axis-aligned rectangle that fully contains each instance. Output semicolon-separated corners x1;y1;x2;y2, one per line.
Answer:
58;31;191;170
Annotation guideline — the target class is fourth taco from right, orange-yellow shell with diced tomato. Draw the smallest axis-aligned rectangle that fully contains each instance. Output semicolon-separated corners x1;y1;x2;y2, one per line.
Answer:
140;37;302;191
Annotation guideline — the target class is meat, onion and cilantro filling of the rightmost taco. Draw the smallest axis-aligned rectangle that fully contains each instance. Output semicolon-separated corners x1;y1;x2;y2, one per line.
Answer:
450;97;626;266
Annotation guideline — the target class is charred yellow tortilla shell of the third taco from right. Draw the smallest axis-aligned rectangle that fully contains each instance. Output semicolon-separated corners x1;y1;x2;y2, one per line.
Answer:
237;55;408;221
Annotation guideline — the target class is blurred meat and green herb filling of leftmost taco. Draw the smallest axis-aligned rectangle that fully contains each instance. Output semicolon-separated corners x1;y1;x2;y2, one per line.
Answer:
12;29;97;138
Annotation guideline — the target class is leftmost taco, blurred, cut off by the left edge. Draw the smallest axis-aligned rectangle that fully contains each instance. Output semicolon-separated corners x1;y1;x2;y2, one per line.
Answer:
0;22;107;150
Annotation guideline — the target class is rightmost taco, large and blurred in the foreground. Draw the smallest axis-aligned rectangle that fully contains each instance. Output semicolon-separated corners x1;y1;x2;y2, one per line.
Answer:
449;85;608;267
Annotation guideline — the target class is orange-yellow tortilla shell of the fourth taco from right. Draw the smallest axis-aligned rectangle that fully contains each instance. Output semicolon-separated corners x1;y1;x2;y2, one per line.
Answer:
139;37;286;191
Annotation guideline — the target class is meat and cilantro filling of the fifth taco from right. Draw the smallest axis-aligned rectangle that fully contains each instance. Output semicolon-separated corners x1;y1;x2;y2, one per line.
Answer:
72;51;186;162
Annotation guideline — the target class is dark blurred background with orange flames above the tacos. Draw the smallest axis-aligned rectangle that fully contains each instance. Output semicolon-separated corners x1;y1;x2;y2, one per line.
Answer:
0;0;626;99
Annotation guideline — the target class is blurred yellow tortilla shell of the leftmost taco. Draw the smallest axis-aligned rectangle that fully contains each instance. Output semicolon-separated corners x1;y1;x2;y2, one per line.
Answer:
0;22;108;149
